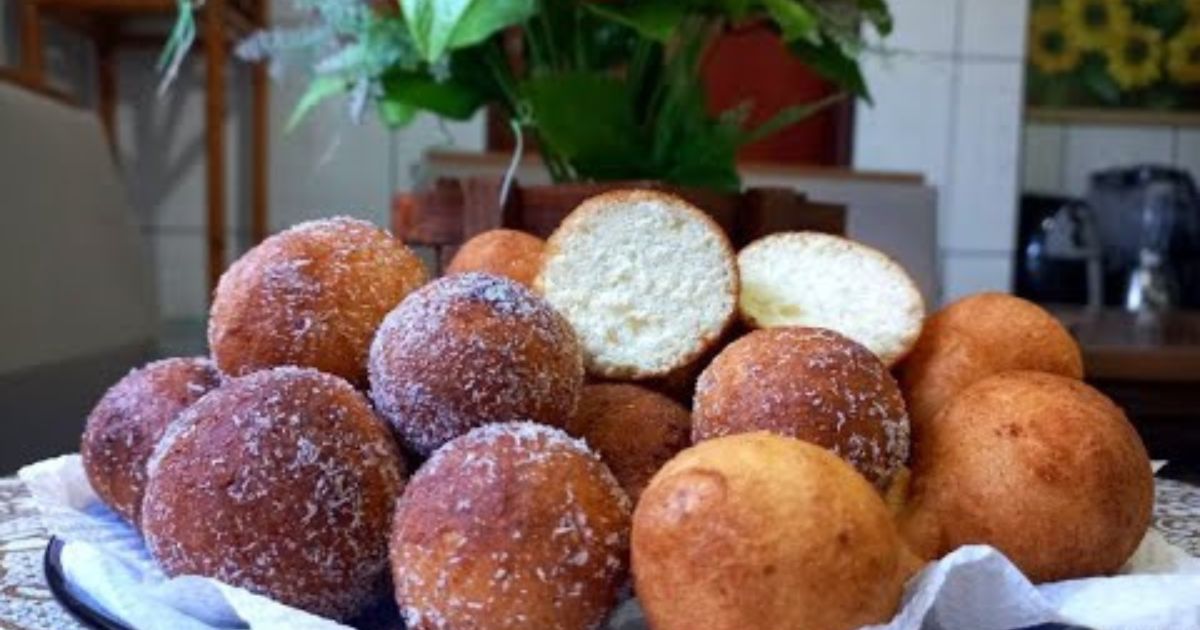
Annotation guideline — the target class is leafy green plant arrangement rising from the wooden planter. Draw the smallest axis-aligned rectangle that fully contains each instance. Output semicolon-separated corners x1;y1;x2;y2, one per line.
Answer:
166;0;892;190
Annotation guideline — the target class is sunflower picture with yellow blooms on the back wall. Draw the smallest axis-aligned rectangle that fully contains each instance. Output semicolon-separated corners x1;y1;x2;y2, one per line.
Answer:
1026;0;1200;125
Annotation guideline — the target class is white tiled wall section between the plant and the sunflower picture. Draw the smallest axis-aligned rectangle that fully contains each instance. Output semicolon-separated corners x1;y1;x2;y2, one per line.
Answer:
854;0;1028;300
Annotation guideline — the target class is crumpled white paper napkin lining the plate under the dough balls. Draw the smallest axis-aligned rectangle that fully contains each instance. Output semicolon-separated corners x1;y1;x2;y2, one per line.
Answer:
19;455;1200;630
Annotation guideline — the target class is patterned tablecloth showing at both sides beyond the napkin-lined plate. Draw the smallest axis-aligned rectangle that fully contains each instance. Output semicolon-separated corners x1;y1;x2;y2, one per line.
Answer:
0;479;1200;630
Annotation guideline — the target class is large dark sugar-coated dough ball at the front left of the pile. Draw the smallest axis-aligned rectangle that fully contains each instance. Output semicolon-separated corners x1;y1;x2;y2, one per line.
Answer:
142;367;404;619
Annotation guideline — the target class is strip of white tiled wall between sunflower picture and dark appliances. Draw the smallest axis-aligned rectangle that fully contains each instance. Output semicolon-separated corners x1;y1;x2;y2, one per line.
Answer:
1021;122;1200;197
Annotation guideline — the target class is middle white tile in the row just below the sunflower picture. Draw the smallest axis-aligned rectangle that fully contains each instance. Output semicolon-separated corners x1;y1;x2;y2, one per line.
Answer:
1063;125;1175;196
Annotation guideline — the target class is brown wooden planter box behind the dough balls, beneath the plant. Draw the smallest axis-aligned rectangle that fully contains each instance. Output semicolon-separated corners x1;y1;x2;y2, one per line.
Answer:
392;176;846;271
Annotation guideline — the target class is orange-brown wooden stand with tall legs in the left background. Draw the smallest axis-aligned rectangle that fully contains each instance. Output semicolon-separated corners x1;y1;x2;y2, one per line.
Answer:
7;0;270;289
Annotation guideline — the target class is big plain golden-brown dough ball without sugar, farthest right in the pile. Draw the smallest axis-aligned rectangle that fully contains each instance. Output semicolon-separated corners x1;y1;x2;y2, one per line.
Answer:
901;372;1154;582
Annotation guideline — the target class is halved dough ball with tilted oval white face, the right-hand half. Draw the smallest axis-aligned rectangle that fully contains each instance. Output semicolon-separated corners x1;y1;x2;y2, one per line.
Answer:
738;232;925;365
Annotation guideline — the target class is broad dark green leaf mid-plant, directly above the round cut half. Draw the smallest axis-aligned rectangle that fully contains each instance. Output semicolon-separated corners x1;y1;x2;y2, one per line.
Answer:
521;72;646;179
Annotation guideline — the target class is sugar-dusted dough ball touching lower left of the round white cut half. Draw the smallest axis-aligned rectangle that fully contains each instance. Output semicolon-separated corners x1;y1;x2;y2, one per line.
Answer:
368;274;583;455
